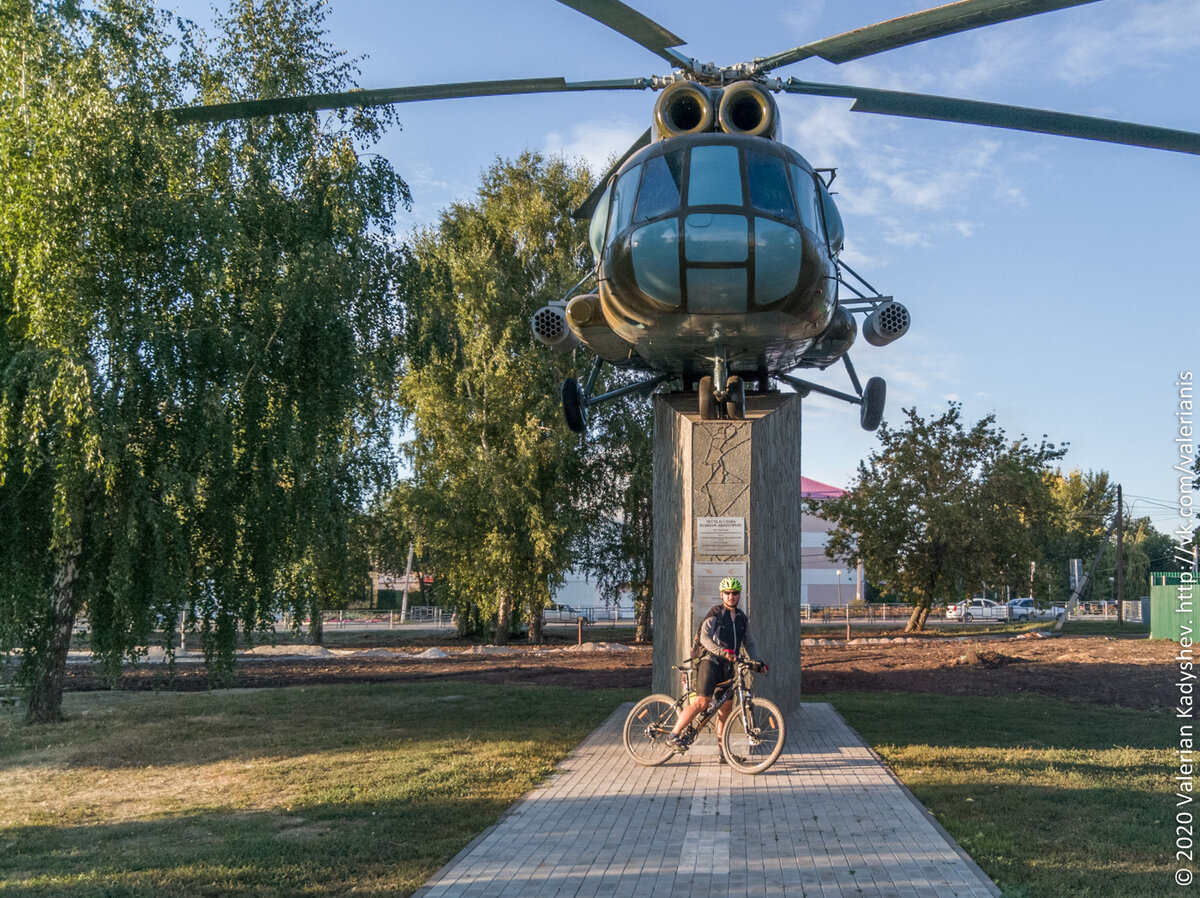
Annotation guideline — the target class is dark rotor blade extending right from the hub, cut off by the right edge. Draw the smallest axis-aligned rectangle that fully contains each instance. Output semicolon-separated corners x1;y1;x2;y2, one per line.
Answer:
784;78;1200;155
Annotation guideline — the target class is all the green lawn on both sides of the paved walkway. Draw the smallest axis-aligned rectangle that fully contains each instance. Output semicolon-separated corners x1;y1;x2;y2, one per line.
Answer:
7;683;1178;898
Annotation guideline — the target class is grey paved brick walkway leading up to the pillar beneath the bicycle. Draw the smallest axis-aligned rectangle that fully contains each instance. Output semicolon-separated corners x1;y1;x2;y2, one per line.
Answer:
414;705;1000;898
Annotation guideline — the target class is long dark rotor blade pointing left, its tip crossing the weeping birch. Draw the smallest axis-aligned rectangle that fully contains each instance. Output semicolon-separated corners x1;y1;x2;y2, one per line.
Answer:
167;78;650;124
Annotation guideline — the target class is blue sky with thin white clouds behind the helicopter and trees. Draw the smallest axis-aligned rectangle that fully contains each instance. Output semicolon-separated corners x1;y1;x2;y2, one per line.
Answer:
179;0;1200;540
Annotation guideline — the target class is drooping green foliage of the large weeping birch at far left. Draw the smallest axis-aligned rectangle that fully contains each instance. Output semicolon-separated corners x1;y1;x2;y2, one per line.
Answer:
0;0;407;719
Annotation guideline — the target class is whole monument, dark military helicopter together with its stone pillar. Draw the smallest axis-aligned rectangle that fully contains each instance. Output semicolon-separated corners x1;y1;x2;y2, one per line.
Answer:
174;0;1200;711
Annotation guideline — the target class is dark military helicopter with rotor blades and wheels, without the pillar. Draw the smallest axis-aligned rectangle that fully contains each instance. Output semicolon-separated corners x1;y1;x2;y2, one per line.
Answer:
168;0;1200;439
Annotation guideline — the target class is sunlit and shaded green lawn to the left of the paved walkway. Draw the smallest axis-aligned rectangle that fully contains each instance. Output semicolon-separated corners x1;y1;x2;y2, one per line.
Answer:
0;683;641;898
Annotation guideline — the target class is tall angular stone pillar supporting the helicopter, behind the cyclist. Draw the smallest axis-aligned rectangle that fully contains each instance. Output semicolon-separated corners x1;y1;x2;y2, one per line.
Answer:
653;394;800;713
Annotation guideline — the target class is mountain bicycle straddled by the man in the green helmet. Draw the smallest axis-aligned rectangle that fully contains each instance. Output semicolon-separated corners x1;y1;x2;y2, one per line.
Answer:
623;658;787;773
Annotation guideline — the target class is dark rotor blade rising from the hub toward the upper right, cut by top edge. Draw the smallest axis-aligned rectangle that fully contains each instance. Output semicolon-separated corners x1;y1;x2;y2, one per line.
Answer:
754;0;1096;72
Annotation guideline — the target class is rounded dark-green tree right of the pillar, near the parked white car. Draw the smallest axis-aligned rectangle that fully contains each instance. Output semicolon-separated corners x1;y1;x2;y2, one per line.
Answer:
812;403;1066;630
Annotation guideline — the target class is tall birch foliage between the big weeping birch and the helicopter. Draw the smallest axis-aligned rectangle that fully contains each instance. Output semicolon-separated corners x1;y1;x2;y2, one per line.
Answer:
400;154;590;641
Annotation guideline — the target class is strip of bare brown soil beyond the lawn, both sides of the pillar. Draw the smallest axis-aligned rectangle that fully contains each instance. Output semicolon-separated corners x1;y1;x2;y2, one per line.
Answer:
60;635;1177;710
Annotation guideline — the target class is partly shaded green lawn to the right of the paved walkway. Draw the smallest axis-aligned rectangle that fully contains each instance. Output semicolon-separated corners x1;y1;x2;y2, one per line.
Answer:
809;691;1180;898
